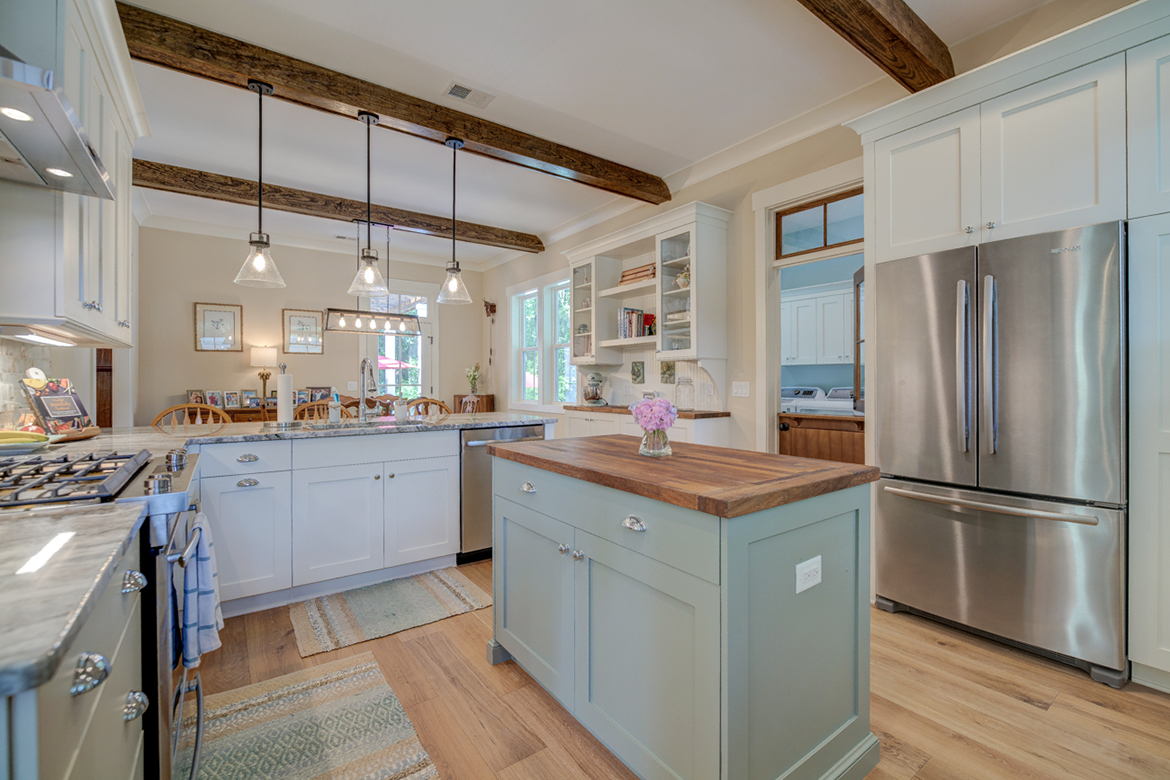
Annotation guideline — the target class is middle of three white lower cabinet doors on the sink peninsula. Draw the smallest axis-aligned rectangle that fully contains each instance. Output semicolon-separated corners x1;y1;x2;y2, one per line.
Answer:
293;463;385;586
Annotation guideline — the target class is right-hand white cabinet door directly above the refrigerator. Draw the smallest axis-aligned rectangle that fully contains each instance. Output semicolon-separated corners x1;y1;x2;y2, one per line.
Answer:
980;54;1126;241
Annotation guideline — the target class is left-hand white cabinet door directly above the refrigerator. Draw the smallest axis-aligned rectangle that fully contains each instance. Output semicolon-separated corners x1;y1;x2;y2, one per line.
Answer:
874;106;979;262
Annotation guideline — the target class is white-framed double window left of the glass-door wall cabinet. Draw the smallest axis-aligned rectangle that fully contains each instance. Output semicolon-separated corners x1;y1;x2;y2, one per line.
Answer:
512;277;577;403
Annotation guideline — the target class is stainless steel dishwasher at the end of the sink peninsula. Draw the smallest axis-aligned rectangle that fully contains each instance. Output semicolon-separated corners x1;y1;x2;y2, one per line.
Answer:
455;426;544;564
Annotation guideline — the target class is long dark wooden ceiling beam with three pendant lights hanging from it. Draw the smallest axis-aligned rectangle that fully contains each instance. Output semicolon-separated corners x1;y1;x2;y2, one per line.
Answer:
118;2;670;203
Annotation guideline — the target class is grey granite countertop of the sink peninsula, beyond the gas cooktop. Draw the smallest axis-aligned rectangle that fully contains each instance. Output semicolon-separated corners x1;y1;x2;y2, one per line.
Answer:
43;412;557;455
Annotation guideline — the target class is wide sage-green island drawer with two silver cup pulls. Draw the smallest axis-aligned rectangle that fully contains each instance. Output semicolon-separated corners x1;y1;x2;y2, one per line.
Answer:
493;458;720;585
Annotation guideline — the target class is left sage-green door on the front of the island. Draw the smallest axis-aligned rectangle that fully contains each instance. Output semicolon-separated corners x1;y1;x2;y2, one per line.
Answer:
493;495;573;711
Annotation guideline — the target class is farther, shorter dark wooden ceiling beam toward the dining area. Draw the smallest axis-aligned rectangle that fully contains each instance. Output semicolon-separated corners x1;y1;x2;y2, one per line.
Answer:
133;160;544;253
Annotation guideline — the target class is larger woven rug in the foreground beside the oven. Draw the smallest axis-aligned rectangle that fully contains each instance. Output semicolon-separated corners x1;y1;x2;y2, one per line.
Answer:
173;653;439;780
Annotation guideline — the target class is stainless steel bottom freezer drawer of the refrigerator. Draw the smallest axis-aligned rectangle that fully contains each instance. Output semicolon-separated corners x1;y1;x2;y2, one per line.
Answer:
874;479;1126;669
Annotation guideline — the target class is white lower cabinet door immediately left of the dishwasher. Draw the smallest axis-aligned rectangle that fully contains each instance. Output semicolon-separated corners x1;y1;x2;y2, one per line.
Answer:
385;455;460;566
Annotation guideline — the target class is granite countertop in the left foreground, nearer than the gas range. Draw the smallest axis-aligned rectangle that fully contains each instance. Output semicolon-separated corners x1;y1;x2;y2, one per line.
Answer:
0;503;146;696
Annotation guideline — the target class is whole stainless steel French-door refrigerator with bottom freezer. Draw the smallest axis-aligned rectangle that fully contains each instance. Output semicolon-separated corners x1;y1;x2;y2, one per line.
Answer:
870;222;1128;686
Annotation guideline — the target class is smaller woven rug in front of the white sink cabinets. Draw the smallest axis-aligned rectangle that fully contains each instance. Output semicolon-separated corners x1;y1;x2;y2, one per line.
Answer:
289;566;491;658
